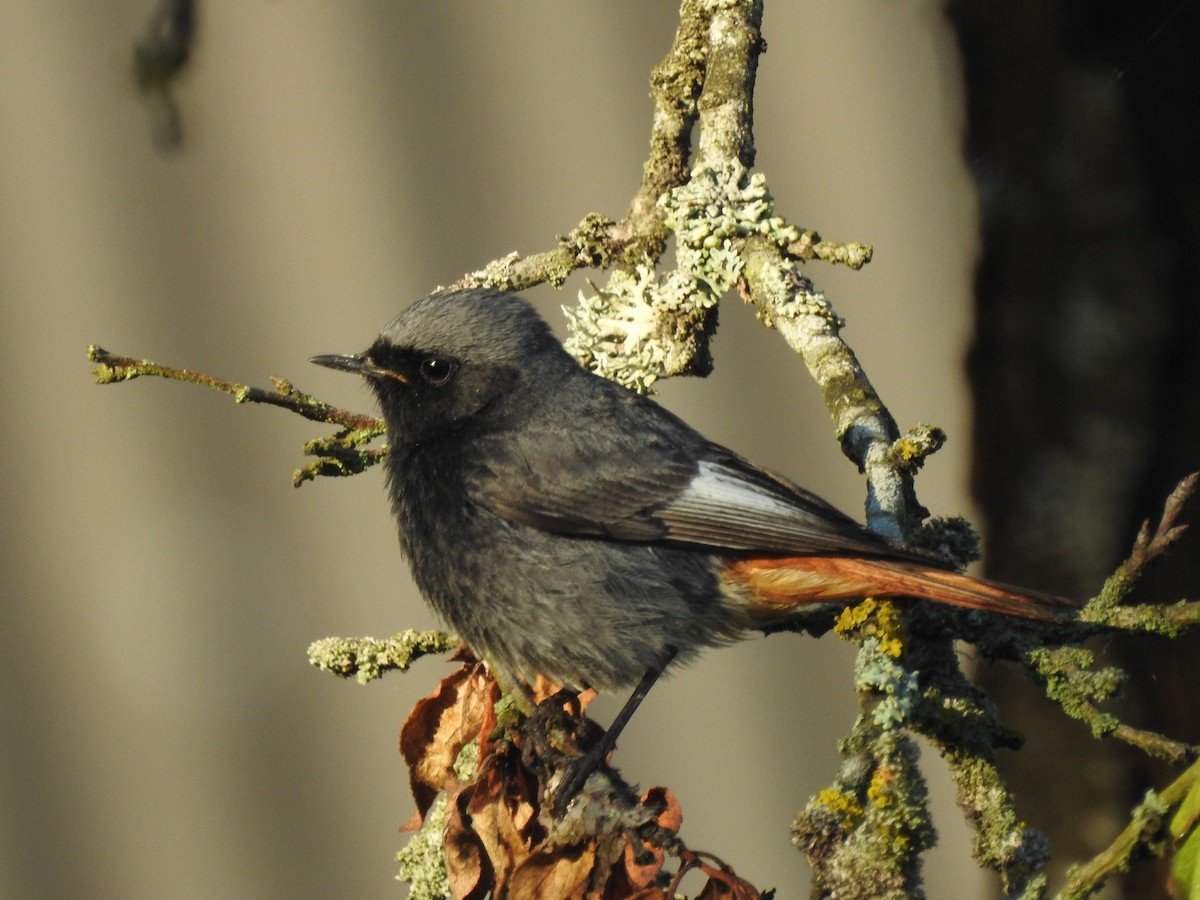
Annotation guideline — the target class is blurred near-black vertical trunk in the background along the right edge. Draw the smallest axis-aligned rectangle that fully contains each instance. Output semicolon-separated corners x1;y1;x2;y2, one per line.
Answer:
948;0;1200;898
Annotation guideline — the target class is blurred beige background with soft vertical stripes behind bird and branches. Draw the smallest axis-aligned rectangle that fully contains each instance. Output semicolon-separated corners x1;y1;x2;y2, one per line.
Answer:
0;0;1190;899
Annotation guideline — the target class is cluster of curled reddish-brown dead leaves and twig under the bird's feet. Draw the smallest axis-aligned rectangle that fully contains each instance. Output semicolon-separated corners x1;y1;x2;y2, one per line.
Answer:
400;648;767;900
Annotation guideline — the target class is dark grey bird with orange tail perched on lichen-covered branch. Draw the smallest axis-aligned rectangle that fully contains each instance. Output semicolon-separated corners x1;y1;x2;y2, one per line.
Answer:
312;288;1073;801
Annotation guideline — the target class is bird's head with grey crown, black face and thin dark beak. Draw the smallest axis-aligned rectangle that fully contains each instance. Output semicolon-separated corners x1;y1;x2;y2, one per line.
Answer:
312;289;580;444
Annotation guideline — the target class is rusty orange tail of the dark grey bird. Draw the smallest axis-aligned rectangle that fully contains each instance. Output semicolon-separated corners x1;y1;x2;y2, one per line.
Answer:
726;557;1079;622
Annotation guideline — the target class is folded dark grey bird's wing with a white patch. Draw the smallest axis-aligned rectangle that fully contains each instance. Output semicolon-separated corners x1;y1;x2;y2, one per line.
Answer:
468;391;910;558
